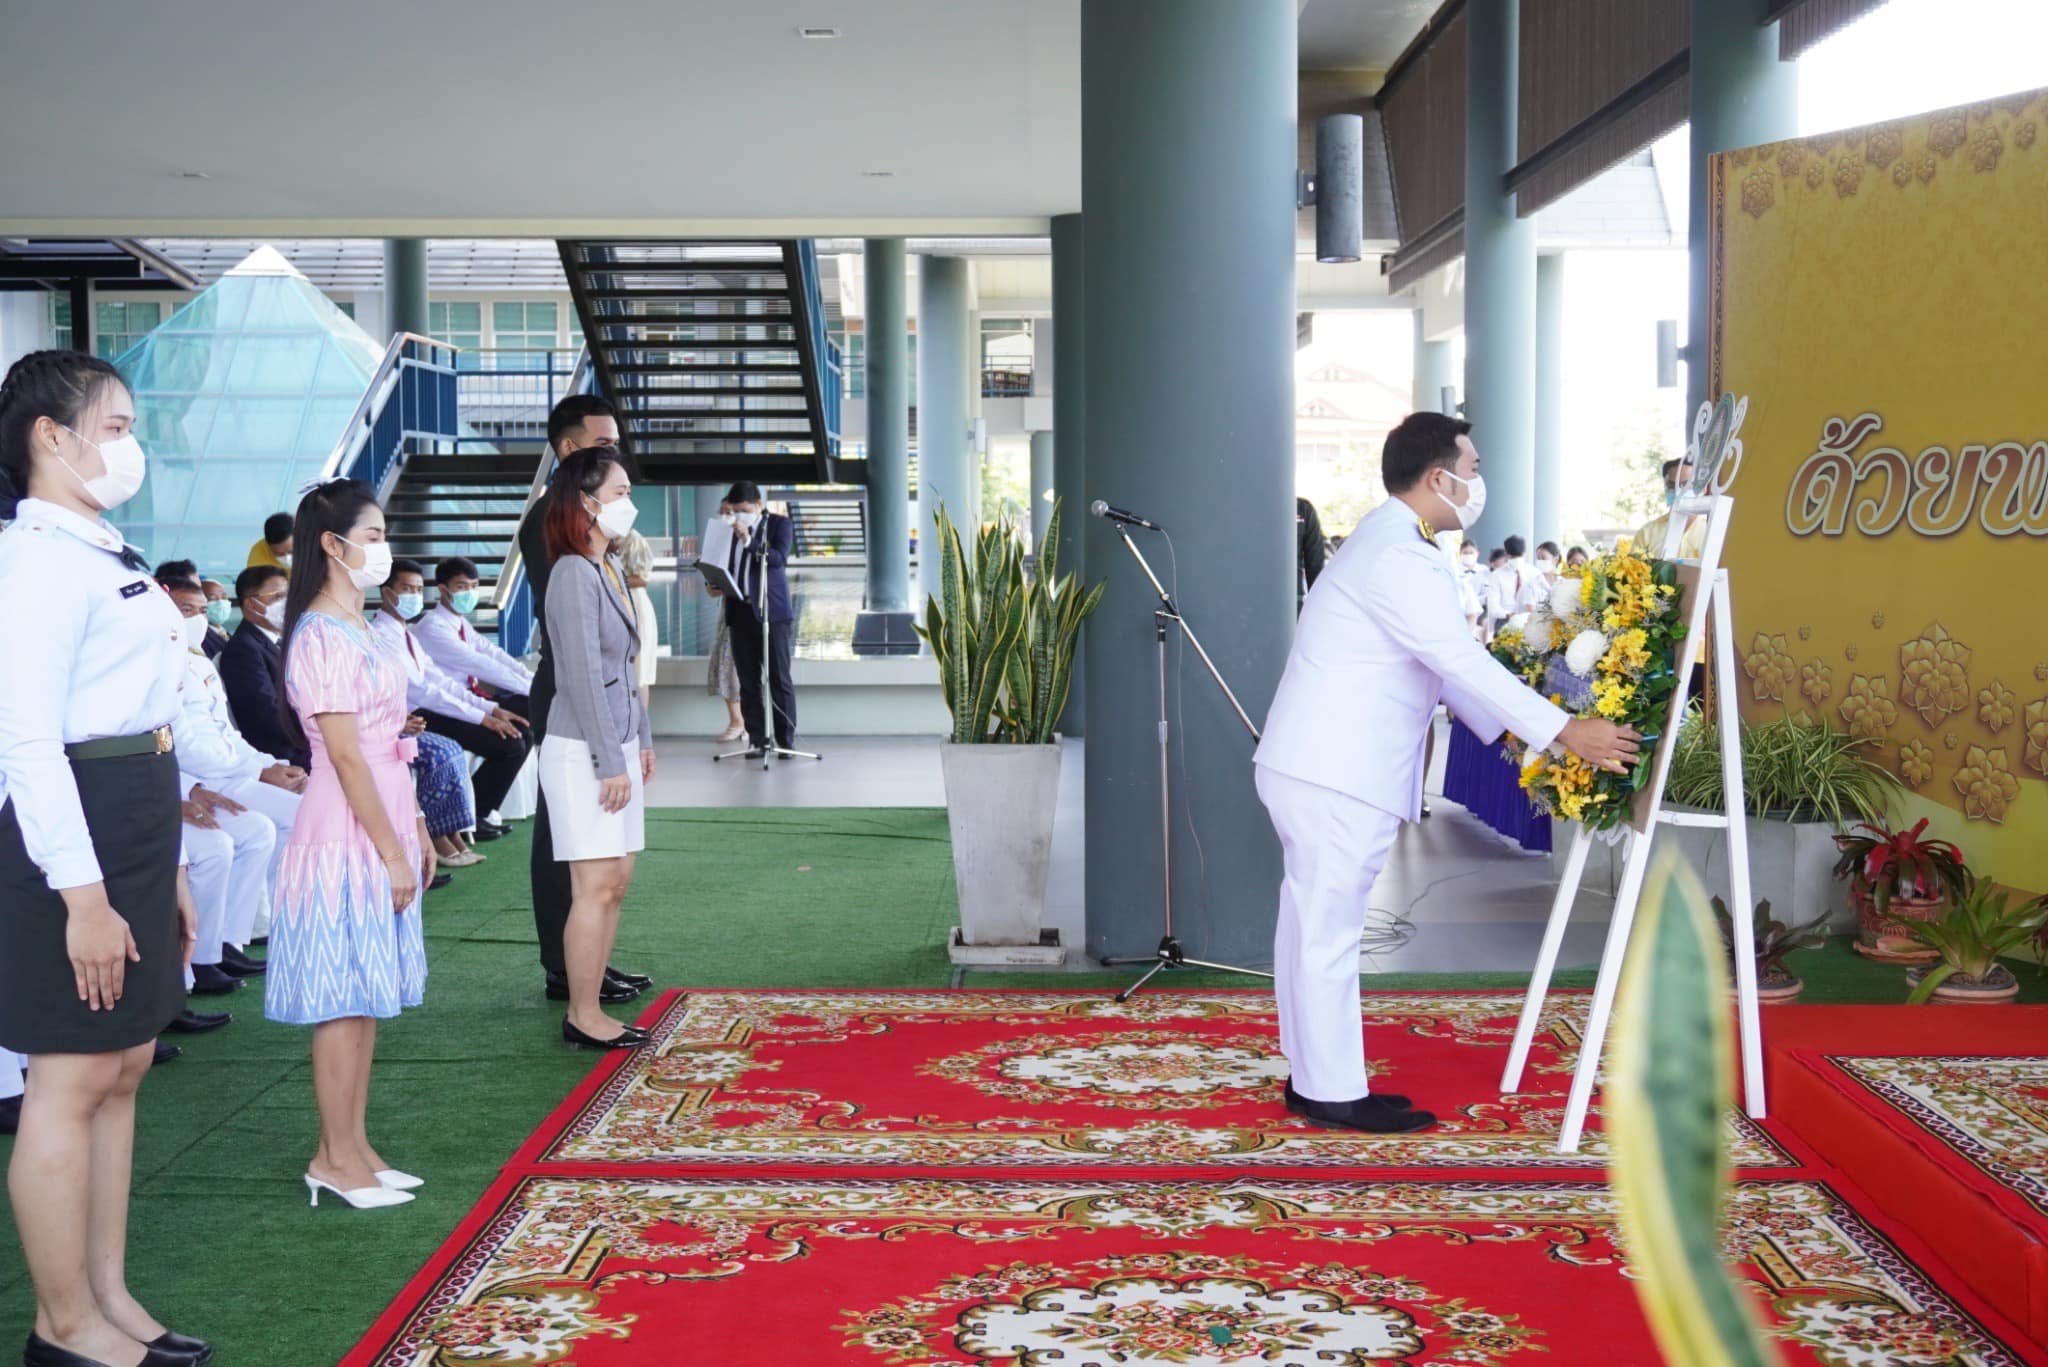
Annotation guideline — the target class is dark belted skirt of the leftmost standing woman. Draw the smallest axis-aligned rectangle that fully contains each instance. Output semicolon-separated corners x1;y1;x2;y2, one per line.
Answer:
0;754;184;1053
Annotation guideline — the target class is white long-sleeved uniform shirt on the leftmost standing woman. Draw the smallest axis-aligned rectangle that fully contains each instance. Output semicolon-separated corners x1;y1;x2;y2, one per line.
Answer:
0;498;188;892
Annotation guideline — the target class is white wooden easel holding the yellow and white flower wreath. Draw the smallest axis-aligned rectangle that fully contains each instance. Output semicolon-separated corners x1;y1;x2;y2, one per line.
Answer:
1501;485;1763;1154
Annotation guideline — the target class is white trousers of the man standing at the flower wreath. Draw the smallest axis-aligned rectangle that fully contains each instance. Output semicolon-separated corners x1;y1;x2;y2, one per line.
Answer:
1257;764;1401;1101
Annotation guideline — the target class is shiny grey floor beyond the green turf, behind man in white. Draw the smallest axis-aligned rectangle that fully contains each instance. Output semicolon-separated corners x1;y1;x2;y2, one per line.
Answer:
647;721;1620;974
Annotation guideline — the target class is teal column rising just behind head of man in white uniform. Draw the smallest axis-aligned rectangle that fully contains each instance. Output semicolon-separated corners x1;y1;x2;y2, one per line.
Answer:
1464;0;1536;545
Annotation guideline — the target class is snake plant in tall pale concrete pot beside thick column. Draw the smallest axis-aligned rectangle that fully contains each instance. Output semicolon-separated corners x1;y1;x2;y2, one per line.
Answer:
918;504;1102;947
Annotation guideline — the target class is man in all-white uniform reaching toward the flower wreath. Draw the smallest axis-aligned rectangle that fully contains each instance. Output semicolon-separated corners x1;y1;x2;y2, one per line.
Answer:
1253;412;1636;1131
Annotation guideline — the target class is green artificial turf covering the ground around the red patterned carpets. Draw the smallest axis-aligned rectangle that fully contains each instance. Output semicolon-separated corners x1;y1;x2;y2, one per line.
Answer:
0;810;2048;1367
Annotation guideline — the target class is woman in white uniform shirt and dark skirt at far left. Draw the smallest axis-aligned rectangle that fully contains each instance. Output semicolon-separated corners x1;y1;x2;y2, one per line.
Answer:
0;350;213;1367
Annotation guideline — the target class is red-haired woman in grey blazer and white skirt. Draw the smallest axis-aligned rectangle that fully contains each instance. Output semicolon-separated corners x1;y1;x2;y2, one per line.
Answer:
541;447;653;1049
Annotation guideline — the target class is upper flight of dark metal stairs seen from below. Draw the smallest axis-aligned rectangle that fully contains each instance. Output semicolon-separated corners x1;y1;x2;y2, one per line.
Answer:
559;238;860;486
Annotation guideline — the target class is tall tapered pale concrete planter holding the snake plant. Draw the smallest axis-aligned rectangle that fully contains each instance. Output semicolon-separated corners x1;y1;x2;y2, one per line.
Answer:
940;742;1059;945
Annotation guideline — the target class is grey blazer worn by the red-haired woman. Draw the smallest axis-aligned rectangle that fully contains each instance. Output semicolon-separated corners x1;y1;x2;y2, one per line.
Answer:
545;555;653;779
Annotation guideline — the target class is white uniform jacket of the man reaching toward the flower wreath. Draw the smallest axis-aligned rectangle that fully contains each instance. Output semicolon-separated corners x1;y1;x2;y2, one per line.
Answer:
1253;498;1569;822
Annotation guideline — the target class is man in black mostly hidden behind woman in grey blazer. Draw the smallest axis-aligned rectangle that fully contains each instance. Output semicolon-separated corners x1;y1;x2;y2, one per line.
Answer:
518;393;653;1004
